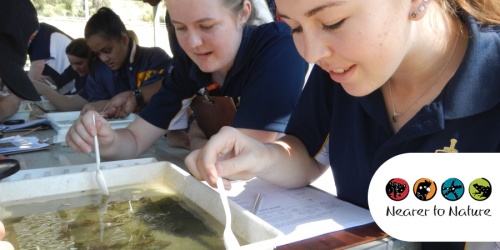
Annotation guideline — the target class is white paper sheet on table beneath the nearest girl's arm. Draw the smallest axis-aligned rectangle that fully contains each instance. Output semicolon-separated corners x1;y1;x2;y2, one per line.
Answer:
228;178;373;244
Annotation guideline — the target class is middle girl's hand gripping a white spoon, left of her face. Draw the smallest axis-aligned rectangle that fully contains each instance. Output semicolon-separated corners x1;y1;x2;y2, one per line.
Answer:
66;111;116;154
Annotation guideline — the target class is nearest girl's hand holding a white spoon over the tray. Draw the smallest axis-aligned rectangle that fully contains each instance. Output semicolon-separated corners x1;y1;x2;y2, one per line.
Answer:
184;127;269;187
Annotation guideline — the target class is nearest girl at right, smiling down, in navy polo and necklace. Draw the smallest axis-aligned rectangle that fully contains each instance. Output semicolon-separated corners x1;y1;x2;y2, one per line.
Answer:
185;0;500;249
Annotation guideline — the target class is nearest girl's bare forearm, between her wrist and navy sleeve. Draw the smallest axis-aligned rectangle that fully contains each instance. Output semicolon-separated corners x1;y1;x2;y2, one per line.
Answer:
257;136;327;188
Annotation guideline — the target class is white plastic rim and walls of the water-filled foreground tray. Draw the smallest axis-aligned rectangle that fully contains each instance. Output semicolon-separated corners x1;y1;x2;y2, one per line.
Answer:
0;162;283;250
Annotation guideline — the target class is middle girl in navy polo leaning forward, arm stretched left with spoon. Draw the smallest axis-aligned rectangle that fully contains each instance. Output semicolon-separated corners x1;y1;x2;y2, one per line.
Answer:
66;0;307;159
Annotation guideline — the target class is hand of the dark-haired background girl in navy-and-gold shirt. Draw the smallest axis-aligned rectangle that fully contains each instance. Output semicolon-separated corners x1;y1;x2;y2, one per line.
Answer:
101;91;137;118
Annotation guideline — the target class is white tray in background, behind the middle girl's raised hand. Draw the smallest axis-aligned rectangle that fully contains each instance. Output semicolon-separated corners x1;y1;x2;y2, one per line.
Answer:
45;111;136;143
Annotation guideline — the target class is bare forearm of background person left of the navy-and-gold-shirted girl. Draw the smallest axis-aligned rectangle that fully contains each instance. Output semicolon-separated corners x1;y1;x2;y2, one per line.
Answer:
32;81;87;111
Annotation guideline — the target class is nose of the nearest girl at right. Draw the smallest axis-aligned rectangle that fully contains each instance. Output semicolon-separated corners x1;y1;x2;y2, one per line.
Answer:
301;30;333;63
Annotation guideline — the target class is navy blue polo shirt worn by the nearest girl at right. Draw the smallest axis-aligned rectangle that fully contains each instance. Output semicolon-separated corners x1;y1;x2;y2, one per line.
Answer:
286;15;500;208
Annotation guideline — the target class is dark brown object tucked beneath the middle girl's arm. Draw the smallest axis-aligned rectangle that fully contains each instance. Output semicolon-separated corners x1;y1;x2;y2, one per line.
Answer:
191;96;236;138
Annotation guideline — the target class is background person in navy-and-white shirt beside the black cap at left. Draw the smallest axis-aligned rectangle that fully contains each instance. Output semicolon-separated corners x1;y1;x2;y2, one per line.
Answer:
28;23;73;84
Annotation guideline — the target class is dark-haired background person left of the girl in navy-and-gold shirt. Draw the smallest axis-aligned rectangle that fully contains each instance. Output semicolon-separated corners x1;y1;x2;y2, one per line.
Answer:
33;38;90;111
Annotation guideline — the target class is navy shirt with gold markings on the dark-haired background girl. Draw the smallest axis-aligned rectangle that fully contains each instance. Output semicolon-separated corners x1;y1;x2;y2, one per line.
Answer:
85;44;172;102
